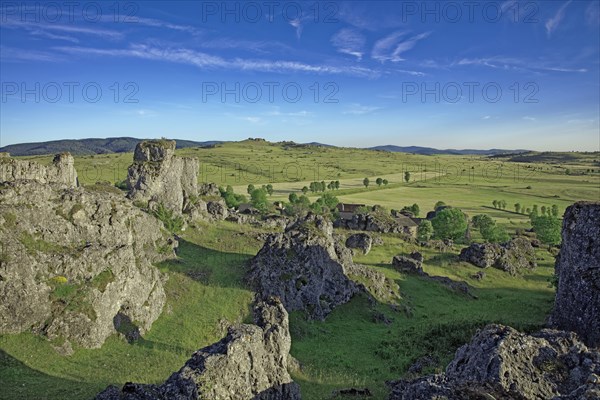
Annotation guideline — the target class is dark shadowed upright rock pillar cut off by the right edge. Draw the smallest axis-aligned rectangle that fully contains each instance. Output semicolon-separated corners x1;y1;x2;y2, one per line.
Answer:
550;202;600;347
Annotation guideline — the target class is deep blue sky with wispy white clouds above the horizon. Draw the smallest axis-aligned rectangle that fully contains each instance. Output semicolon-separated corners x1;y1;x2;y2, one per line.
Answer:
0;0;600;151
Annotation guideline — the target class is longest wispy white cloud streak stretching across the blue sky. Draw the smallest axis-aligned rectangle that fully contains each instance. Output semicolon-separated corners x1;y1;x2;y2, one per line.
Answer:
53;44;382;78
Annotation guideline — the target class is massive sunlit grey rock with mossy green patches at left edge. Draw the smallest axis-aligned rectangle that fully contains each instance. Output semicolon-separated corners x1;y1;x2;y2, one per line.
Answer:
0;180;173;348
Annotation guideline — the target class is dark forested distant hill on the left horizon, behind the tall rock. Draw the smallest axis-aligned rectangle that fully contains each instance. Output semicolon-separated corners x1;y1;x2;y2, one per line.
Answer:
0;137;222;156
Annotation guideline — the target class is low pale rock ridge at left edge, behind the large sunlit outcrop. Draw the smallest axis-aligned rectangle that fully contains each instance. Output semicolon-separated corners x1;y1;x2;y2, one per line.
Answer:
0;153;79;187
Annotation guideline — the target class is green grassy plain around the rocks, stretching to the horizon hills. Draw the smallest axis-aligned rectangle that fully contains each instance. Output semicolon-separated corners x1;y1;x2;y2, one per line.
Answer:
0;141;600;400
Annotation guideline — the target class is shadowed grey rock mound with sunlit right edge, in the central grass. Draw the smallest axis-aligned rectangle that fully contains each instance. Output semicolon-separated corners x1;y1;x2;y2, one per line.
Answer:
248;214;396;319
